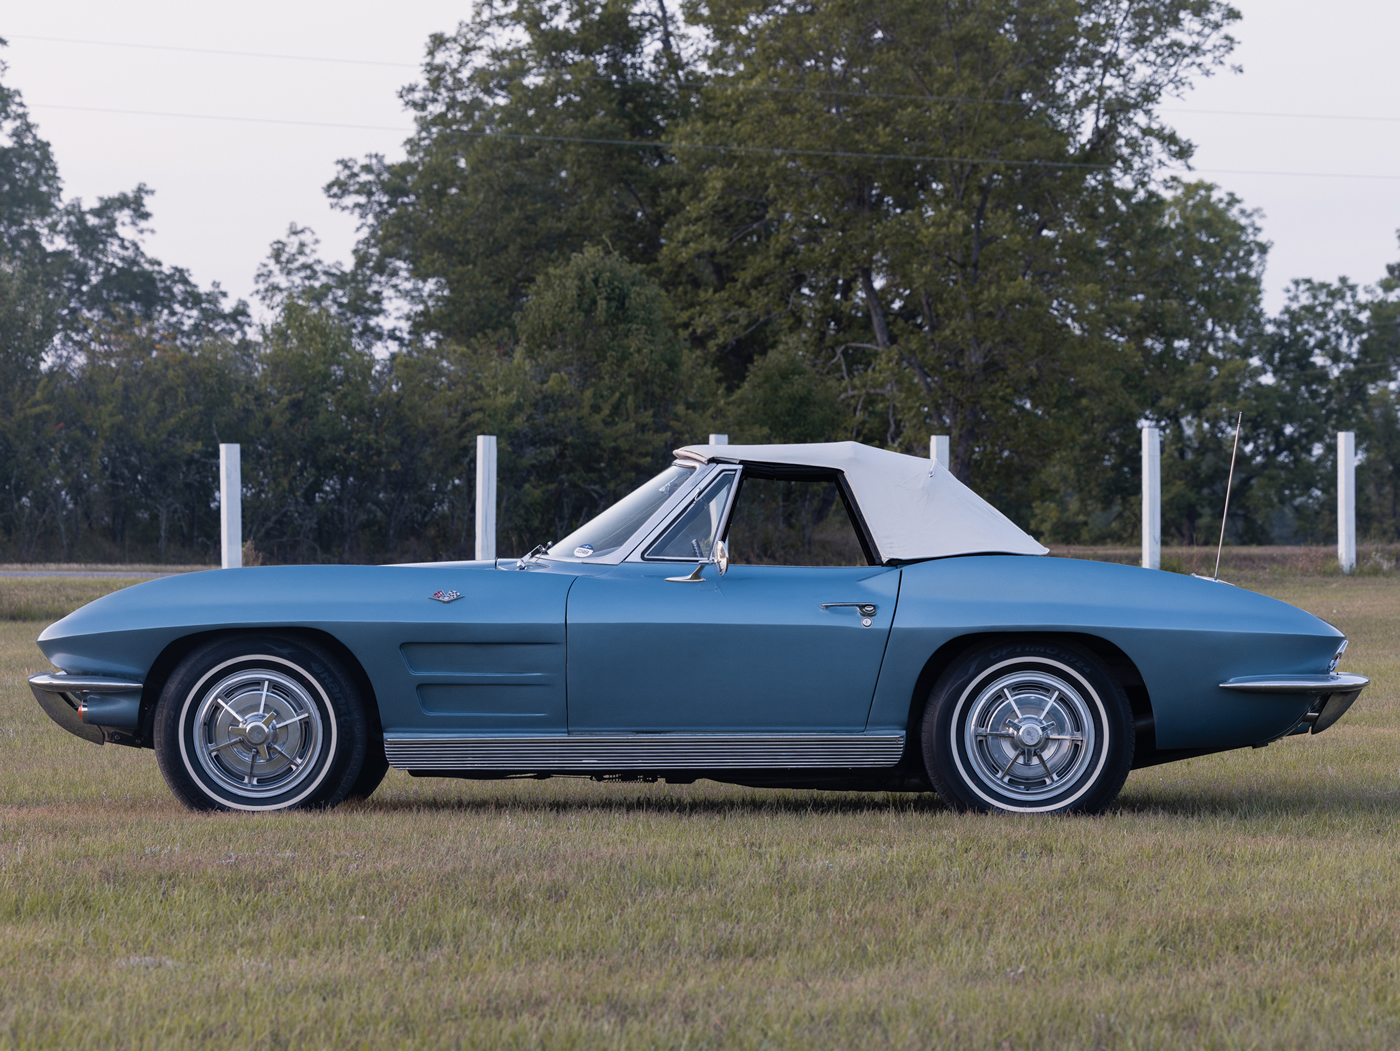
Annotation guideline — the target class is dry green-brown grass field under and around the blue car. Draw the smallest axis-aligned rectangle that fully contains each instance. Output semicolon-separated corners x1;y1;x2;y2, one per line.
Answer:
0;575;1400;1050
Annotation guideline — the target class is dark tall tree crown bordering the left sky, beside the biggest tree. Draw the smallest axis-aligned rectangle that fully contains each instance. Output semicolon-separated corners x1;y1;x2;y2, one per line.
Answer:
328;0;700;343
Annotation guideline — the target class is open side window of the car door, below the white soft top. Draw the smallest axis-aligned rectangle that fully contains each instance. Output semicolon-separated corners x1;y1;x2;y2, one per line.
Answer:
727;470;869;565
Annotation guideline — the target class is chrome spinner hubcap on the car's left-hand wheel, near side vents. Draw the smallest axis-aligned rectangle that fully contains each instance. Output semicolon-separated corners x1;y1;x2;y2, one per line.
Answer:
195;668;325;798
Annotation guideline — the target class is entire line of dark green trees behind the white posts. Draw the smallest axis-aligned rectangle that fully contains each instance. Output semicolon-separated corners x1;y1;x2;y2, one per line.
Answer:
0;0;1400;561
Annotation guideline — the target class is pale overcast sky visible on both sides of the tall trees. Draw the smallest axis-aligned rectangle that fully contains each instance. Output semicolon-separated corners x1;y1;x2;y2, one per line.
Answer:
0;0;1400;320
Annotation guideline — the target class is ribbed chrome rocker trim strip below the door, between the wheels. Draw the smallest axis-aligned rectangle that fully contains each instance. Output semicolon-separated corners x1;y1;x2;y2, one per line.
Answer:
384;732;904;773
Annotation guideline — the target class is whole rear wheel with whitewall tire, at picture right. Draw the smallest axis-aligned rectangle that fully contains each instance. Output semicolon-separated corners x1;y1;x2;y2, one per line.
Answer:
923;641;1134;813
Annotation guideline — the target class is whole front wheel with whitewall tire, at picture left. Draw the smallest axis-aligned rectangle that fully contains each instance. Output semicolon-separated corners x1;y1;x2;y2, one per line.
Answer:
154;635;369;810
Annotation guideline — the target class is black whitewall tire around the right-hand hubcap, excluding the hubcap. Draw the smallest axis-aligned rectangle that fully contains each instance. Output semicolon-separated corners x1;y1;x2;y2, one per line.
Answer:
921;641;1134;814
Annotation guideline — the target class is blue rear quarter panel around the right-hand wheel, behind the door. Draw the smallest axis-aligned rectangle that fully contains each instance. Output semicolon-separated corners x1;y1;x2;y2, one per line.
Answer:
869;556;1343;750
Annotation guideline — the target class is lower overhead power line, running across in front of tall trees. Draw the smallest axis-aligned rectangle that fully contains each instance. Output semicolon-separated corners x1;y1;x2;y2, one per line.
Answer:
31;102;1400;181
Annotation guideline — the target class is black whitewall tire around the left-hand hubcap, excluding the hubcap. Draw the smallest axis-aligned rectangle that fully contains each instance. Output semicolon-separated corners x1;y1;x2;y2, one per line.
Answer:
154;634;368;813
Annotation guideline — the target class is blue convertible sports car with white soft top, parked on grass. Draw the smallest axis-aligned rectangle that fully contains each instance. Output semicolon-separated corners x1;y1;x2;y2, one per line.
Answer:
29;442;1368;813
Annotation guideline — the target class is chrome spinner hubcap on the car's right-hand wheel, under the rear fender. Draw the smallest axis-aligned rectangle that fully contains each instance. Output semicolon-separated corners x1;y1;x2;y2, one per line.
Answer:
963;670;1095;802
